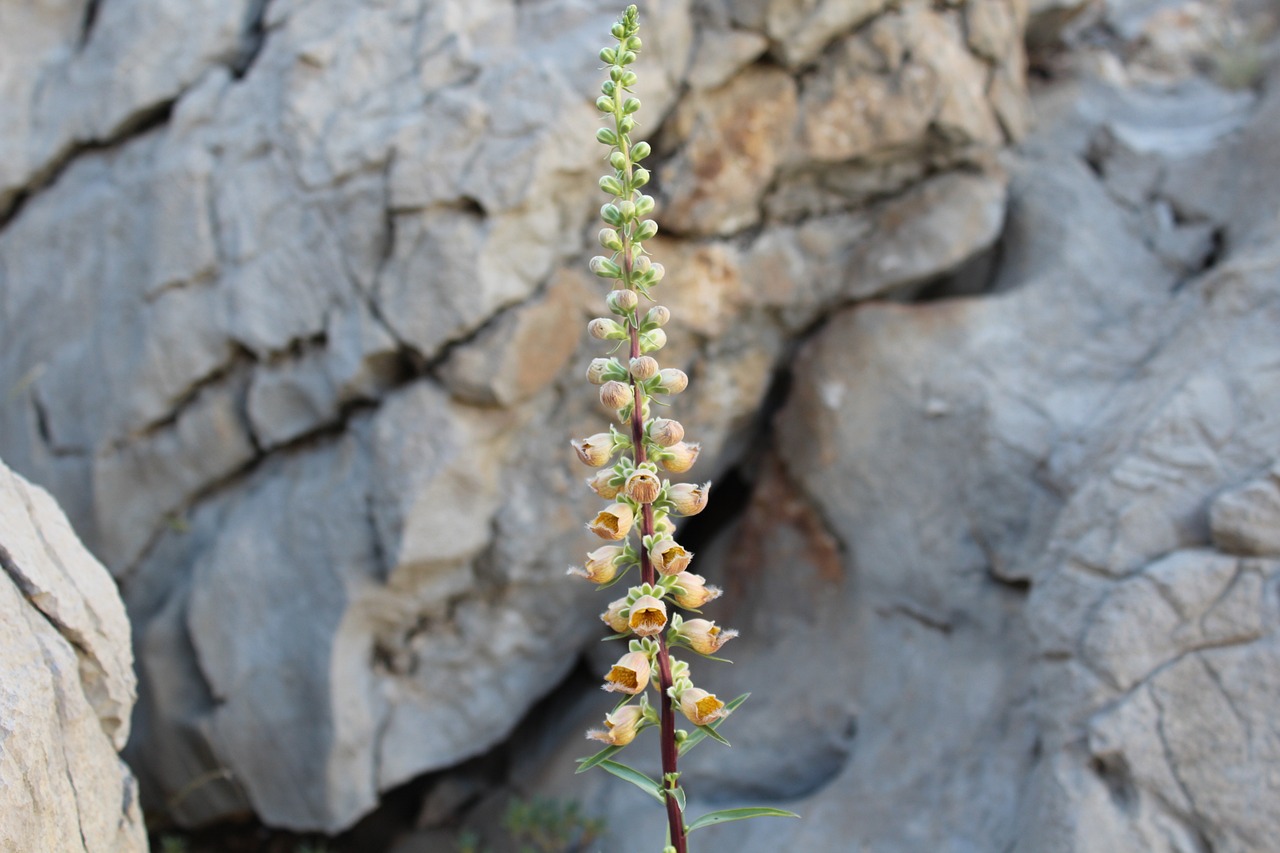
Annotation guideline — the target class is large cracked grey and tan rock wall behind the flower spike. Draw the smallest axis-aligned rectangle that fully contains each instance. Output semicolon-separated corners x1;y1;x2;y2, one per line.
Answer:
0;0;1280;853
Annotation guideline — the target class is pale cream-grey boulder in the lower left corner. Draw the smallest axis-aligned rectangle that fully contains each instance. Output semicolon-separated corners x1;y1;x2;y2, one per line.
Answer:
0;465;147;853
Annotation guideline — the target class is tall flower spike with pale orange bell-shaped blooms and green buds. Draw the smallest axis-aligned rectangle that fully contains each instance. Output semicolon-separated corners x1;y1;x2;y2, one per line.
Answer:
570;5;794;853
